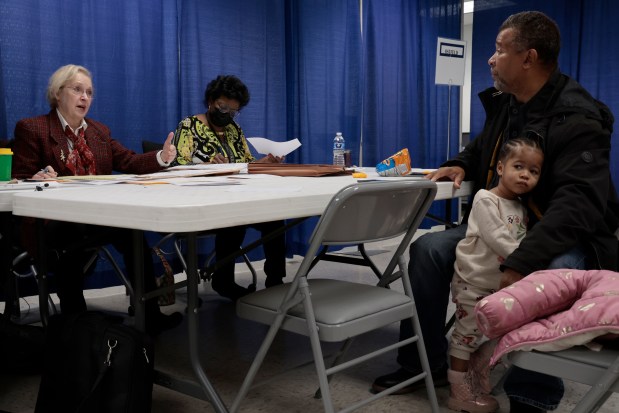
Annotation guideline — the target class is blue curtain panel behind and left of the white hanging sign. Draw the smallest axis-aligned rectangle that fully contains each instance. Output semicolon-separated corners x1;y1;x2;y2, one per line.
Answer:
363;0;462;225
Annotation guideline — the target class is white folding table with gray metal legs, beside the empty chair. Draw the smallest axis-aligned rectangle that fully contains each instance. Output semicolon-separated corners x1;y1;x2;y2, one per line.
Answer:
12;175;472;412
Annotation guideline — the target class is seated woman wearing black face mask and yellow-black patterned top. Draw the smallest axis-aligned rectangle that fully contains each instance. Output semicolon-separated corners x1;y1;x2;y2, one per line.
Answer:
172;75;286;300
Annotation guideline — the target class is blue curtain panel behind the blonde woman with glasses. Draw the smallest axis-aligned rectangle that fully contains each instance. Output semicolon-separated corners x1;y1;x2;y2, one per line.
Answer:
0;0;178;150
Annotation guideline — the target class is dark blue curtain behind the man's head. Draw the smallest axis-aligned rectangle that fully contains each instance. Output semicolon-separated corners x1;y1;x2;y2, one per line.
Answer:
471;0;619;183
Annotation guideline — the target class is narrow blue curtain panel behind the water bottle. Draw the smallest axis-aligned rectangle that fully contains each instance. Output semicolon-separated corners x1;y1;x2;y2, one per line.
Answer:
286;0;361;163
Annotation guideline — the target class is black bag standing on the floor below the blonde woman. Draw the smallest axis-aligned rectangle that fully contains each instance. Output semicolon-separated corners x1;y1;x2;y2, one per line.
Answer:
35;311;154;413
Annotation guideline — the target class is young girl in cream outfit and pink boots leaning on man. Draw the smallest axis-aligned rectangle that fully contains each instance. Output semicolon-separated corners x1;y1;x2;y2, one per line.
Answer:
447;137;544;413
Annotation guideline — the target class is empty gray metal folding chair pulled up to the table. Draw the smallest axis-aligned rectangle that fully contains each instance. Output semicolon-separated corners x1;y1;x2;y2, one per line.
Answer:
231;180;439;412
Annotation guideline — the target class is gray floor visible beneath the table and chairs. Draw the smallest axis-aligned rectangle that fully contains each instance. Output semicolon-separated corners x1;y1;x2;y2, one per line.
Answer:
0;235;619;413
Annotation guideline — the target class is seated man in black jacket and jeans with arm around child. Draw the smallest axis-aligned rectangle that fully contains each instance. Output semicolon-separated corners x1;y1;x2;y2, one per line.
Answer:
372;12;619;413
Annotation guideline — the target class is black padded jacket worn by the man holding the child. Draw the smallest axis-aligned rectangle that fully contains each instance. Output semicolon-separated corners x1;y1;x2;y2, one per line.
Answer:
442;71;619;275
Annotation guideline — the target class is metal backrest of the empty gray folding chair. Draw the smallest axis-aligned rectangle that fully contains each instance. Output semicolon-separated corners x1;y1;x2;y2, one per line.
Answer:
302;179;437;273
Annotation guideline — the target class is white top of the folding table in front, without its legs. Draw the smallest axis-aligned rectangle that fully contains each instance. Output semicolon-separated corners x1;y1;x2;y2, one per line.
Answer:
9;176;472;232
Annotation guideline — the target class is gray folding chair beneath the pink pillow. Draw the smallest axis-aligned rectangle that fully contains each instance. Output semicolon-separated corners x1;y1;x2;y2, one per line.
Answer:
507;346;619;413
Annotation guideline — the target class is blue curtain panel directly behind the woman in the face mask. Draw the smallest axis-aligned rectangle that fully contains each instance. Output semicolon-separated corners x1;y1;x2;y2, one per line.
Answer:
173;0;288;145
